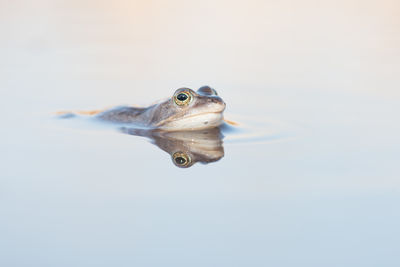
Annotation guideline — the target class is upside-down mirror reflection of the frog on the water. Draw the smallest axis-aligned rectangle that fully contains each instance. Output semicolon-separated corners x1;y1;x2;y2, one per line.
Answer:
121;127;224;168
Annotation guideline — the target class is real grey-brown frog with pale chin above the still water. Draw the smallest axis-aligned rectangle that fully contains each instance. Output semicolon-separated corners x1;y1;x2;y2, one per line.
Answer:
97;86;226;131
